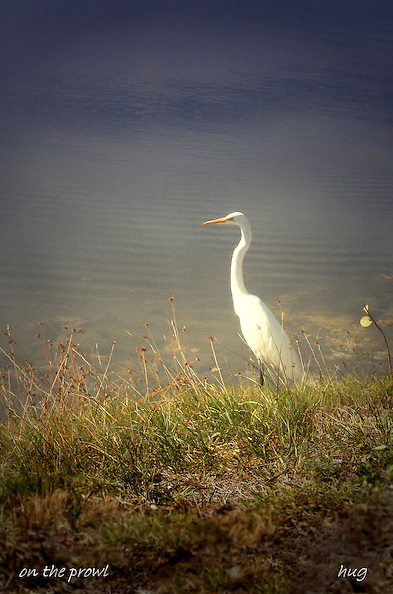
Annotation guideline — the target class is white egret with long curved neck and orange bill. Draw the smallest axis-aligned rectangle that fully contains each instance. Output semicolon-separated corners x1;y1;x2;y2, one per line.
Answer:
203;212;303;385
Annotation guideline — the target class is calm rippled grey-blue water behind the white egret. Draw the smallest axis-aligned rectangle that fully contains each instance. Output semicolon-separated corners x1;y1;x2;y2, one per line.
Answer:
0;8;393;374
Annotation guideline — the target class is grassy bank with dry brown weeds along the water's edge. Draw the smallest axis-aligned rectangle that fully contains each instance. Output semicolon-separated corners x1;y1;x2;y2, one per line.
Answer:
0;310;393;594
